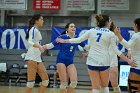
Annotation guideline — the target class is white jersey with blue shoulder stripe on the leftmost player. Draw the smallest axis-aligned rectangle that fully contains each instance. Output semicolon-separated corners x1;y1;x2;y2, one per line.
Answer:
25;27;42;62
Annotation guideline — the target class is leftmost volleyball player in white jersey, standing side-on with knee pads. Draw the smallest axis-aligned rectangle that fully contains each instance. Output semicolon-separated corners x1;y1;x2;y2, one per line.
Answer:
25;14;49;93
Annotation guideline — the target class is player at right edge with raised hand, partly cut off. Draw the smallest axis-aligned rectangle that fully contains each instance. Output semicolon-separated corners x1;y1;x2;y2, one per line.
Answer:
115;18;140;93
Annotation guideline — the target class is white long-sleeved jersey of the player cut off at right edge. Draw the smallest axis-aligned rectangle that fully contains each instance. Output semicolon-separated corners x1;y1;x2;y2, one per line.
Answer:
121;32;140;69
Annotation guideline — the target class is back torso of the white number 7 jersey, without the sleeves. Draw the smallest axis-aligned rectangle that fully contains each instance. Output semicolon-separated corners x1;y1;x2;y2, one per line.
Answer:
88;28;113;65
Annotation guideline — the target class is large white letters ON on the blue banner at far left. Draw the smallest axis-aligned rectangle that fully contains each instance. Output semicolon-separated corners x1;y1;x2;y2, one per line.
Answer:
0;29;28;49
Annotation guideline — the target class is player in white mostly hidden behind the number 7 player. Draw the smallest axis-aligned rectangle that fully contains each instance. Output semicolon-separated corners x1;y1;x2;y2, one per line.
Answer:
109;22;121;93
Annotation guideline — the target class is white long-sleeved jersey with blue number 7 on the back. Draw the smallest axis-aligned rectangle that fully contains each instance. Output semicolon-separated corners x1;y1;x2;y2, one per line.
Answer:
69;27;122;66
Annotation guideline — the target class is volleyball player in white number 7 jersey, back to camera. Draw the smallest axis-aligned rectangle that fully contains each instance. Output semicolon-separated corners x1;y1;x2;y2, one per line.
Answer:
57;15;136;93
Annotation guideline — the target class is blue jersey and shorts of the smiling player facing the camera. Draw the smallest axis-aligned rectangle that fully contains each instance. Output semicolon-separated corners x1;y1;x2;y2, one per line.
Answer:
46;34;85;66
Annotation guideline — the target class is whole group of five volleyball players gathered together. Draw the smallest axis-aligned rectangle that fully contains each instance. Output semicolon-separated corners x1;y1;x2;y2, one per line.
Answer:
25;15;140;93
